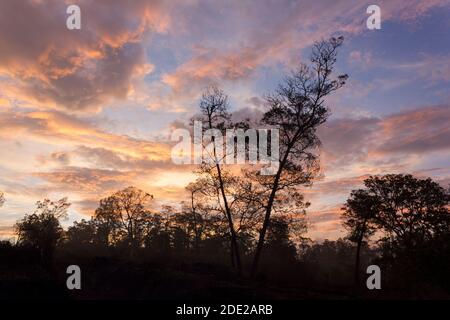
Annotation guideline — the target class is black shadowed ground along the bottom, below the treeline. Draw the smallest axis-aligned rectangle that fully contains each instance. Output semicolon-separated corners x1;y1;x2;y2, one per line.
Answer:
0;245;450;303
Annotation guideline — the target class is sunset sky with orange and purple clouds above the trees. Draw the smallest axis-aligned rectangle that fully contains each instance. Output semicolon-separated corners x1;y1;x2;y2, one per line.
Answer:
0;0;450;240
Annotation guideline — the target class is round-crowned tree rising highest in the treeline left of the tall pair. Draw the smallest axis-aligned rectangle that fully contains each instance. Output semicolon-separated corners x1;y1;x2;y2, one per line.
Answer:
95;187;153;255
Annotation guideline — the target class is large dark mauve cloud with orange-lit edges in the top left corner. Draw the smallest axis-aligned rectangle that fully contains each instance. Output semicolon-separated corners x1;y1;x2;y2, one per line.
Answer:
0;0;169;111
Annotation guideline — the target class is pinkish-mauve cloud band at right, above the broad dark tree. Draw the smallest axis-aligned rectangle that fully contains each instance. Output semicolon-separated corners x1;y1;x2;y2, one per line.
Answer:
319;105;450;167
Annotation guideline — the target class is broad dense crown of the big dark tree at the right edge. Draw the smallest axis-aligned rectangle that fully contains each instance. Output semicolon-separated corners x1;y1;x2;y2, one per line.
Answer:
364;174;450;249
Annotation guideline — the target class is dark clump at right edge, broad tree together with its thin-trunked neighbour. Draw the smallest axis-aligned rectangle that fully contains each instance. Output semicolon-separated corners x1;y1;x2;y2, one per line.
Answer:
344;174;450;288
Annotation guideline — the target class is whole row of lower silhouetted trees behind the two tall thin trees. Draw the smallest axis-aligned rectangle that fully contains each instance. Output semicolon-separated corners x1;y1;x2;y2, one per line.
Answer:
4;174;450;294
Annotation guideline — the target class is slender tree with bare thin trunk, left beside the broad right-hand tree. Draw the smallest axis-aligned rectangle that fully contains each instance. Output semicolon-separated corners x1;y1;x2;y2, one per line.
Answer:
343;189;378;286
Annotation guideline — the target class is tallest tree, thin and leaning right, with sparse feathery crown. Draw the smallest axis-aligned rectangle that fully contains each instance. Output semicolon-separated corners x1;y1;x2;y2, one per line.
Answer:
252;37;348;276
